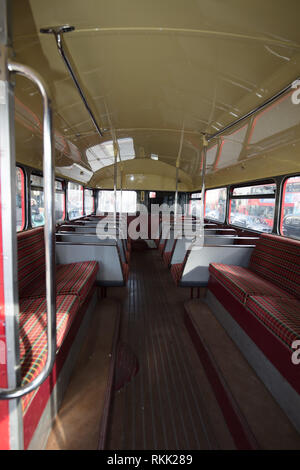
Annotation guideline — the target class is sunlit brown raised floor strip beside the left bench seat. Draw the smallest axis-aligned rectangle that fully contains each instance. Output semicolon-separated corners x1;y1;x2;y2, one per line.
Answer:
46;299;120;450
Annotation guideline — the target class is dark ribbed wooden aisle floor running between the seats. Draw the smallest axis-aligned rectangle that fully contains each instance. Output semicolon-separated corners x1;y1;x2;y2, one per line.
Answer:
107;250;235;450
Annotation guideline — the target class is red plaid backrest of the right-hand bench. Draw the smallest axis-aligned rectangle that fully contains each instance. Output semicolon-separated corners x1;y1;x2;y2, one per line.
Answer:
249;234;300;298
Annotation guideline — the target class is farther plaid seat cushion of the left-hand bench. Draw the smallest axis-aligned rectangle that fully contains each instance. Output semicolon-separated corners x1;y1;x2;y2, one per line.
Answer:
22;261;99;303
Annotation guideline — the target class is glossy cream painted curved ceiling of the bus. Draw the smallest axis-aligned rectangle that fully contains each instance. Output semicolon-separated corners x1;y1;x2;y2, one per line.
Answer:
13;0;300;190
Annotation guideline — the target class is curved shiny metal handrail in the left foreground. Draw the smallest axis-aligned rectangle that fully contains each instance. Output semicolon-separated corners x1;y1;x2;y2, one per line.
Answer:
0;62;56;400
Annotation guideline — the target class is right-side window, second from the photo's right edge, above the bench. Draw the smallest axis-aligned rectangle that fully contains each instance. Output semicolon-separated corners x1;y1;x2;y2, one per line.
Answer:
229;183;276;233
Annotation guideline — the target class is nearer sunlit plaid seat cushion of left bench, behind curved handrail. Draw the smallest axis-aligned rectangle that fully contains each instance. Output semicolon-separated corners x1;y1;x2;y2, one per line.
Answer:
20;295;79;413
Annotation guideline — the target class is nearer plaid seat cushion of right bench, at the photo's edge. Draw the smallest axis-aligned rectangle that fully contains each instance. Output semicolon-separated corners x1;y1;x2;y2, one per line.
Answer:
246;295;300;349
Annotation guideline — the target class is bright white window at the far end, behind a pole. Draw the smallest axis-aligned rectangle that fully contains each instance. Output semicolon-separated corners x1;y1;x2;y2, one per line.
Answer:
98;191;136;213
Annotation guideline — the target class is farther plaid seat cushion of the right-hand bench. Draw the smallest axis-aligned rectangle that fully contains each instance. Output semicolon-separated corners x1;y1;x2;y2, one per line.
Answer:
209;263;289;303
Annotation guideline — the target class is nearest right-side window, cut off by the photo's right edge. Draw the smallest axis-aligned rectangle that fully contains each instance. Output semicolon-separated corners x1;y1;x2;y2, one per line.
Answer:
280;176;300;240
